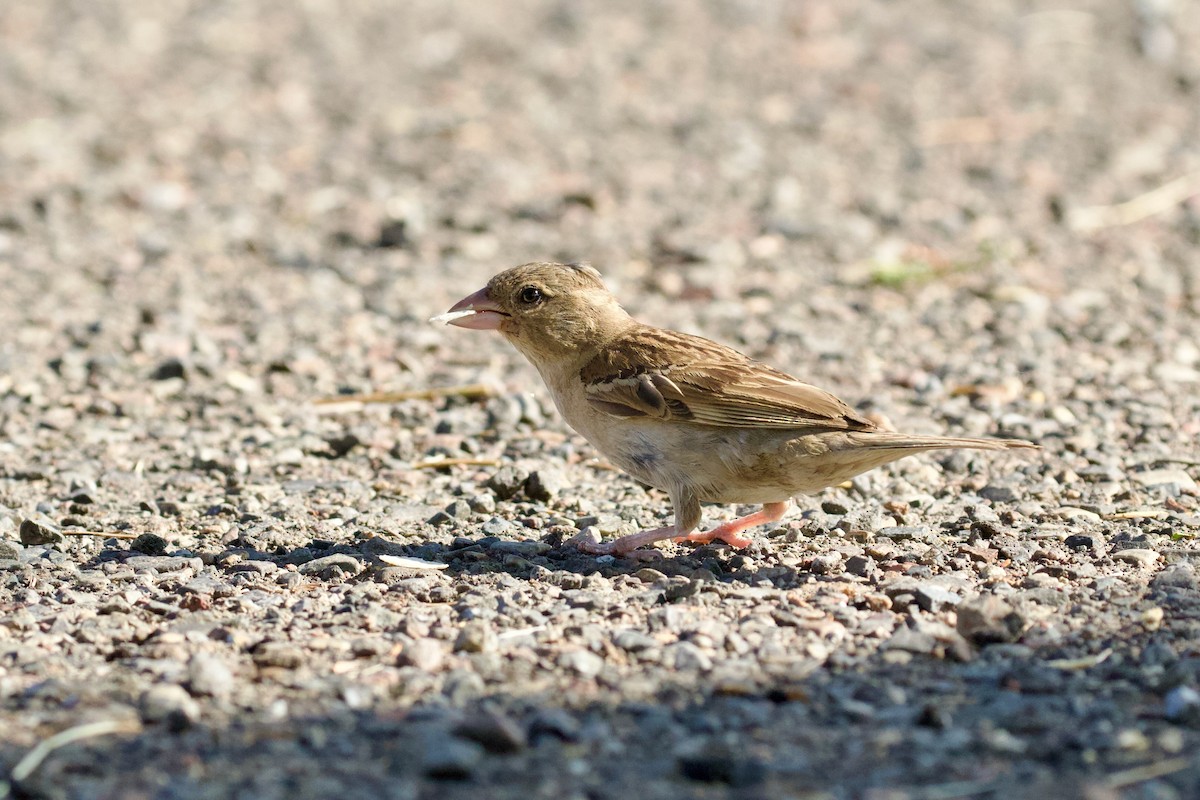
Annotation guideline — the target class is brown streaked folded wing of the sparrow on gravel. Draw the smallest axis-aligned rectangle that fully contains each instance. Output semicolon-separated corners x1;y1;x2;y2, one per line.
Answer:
580;326;875;431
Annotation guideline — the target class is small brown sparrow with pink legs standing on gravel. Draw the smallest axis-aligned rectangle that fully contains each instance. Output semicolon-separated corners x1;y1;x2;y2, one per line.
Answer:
431;261;1037;555
